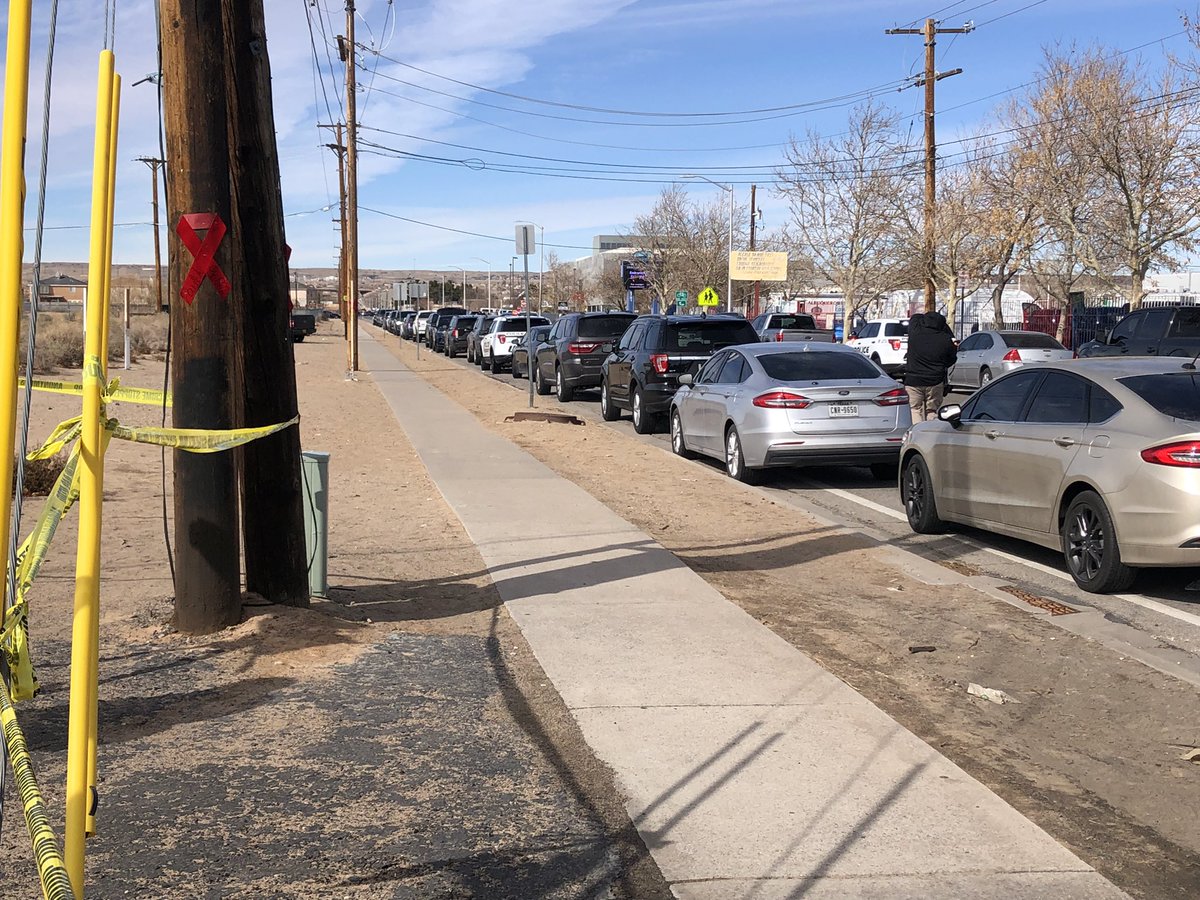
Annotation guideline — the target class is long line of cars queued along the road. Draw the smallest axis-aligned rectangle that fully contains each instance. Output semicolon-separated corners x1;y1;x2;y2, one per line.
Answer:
367;312;1200;593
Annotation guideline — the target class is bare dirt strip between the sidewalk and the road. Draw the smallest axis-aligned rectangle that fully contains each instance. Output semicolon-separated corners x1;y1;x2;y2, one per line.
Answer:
381;329;1200;899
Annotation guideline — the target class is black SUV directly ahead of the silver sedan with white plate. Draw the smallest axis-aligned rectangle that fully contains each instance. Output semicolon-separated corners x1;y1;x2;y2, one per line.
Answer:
600;316;760;434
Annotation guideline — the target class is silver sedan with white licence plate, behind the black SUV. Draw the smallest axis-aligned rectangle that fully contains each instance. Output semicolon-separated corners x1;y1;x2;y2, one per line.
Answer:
671;343;912;482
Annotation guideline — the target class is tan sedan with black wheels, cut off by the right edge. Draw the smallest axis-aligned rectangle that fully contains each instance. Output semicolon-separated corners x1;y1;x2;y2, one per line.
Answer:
900;359;1200;593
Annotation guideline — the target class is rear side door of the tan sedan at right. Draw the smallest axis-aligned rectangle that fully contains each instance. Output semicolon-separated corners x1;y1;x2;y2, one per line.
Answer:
994;370;1090;533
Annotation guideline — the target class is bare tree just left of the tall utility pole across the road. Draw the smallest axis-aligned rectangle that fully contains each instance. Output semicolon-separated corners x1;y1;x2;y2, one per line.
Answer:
778;102;919;322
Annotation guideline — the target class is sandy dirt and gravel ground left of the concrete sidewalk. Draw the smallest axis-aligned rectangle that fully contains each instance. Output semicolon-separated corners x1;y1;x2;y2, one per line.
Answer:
0;323;668;900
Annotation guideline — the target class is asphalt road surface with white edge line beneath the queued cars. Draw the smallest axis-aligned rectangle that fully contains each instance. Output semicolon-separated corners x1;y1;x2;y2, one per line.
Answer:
392;338;1200;679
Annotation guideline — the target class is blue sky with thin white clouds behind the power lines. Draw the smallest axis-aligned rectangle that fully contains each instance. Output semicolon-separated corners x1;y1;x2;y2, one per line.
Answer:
7;0;1190;271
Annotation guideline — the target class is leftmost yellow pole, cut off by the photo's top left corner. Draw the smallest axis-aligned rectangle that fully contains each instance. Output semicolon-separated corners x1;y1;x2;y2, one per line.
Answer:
0;0;36;657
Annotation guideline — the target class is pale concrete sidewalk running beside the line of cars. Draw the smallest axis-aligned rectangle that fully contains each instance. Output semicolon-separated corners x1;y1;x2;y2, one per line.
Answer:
361;332;1124;900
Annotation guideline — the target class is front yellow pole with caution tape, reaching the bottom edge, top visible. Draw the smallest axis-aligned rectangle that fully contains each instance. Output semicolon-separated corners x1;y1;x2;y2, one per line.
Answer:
64;50;114;898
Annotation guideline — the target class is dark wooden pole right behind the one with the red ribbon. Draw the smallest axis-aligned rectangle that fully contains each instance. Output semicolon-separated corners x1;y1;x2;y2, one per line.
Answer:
221;0;308;606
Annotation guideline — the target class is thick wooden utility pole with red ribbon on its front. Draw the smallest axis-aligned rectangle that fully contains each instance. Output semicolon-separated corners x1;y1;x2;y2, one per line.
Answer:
161;0;244;634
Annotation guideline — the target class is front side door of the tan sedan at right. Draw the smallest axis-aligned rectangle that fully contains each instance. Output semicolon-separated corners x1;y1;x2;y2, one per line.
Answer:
931;370;1043;522
